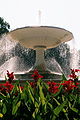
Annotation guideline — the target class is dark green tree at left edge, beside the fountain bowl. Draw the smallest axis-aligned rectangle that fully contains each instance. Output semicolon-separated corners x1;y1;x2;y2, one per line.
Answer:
0;17;10;36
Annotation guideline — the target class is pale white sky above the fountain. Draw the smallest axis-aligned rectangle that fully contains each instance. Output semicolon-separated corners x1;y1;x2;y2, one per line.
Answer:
0;0;80;49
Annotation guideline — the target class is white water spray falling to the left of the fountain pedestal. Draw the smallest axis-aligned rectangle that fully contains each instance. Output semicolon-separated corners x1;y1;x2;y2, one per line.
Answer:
0;36;29;78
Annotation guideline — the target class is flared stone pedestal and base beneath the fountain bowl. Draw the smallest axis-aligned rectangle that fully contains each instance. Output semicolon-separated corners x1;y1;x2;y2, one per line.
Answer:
15;46;62;80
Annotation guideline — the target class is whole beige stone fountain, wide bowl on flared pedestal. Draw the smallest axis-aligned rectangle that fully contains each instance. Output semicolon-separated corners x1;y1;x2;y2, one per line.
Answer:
6;26;73;78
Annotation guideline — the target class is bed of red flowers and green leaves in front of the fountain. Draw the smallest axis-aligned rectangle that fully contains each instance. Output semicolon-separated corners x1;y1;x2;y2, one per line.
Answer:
0;69;80;120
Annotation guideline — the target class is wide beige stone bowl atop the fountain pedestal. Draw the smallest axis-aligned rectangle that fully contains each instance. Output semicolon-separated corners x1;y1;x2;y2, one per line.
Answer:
7;26;73;49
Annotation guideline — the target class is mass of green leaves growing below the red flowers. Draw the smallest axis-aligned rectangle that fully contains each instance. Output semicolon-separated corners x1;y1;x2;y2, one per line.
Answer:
0;75;80;120
